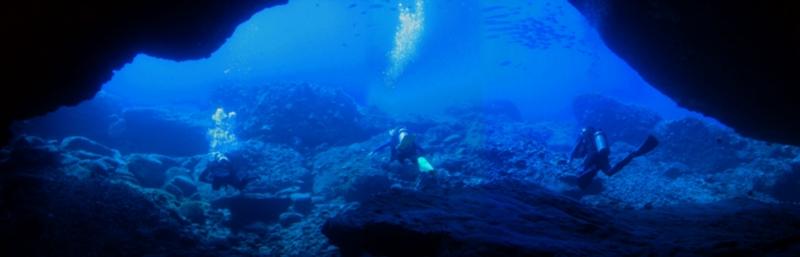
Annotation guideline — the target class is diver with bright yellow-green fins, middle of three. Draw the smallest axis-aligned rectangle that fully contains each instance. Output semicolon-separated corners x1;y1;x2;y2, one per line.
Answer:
369;127;434;172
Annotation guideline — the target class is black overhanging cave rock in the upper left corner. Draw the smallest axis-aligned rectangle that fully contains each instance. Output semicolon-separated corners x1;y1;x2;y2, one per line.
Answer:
0;0;287;145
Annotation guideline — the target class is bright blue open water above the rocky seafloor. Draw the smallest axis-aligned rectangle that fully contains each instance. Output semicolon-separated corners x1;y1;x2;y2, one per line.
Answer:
103;0;688;120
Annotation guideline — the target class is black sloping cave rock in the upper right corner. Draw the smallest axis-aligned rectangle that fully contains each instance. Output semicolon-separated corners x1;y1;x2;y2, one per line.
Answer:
570;0;800;145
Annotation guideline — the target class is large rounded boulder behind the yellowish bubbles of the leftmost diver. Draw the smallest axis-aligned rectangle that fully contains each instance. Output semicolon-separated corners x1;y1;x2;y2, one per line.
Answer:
216;83;371;149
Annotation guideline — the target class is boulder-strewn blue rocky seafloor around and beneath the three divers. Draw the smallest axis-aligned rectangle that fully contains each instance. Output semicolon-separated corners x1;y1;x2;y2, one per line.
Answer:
0;83;800;256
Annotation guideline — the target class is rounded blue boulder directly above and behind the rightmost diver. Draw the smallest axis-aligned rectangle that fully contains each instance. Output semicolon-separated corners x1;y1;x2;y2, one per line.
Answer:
572;94;661;145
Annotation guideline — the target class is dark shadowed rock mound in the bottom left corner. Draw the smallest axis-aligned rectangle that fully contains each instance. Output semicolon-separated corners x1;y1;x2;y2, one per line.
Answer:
0;172;215;256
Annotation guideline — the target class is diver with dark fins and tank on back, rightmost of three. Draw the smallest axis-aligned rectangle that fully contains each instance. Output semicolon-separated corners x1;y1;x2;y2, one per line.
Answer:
568;127;658;189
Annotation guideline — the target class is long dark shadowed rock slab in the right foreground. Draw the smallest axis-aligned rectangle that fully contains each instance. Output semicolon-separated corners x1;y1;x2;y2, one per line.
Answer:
323;181;800;256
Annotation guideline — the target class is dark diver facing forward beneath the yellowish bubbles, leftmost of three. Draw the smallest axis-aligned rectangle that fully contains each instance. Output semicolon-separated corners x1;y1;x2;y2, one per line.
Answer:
200;152;256;191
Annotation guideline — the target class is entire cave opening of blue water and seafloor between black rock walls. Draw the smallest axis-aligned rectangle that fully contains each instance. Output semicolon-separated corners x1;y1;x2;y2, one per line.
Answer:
0;0;800;256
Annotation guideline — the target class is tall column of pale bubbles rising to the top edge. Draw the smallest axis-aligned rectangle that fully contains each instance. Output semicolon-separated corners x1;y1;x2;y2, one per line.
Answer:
386;0;425;85
